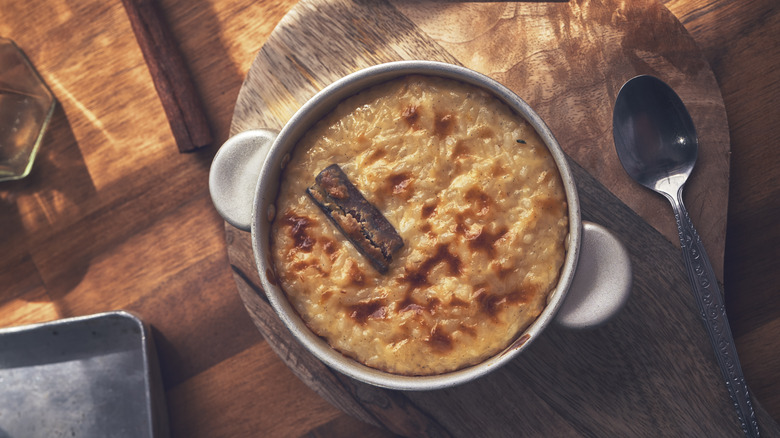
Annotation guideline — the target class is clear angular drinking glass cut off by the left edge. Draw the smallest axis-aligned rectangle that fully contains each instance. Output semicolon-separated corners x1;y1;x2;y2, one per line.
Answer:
0;38;55;181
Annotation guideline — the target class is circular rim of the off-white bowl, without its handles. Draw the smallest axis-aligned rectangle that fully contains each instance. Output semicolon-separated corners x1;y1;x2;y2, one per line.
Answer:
251;61;582;390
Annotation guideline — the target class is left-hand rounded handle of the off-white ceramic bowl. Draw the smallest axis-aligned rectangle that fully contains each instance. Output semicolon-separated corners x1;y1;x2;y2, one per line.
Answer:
209;129;279;231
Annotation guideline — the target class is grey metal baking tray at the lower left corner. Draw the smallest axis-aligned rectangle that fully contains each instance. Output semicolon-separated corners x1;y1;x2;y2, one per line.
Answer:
0;311;169;438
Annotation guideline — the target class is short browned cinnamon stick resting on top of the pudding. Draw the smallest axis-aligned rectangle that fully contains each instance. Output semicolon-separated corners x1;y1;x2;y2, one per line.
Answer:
306;164;404;274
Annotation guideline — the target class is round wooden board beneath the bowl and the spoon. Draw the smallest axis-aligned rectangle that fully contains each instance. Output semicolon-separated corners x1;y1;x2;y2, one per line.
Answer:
226;0;780;436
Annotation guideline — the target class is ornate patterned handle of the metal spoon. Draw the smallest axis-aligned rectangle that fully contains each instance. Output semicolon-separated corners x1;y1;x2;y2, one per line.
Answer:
669;193;759;437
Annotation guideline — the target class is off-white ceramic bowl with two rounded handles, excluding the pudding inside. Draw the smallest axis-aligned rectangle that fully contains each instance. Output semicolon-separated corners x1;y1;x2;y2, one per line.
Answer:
209;61;631;390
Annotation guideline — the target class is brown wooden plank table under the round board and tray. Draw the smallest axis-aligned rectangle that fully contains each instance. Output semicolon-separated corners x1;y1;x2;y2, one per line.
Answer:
0;0;780;436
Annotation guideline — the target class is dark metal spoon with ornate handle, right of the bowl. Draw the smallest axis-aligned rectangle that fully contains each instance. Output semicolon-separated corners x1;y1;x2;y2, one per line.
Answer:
612;76;759;437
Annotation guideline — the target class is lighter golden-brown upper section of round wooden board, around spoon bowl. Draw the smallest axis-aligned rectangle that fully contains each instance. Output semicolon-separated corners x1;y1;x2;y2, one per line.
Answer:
231;1;730;279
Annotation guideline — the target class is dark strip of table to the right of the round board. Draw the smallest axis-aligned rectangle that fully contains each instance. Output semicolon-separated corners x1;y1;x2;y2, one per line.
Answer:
667;0;780;418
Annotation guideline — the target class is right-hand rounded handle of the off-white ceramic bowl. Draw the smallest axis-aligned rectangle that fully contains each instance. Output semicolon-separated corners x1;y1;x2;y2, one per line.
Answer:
555;221;632;329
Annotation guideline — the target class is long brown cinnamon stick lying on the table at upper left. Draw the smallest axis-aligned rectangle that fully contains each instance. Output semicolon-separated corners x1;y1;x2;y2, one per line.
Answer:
122;0;212;152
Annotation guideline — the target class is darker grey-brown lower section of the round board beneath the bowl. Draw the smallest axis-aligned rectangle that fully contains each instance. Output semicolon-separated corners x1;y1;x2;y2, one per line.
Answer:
226;157;780;437
